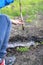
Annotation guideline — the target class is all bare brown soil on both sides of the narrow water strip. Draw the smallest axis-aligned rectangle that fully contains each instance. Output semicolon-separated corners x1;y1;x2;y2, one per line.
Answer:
7;15;43;65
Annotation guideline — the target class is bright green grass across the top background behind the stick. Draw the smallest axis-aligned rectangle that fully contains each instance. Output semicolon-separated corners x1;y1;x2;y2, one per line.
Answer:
0;0;43;21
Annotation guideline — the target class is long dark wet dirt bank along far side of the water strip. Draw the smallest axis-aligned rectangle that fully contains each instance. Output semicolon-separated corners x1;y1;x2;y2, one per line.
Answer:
9;34;43;43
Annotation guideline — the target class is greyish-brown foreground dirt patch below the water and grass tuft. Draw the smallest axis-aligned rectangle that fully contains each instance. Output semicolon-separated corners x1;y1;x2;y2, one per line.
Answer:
8;45;43;65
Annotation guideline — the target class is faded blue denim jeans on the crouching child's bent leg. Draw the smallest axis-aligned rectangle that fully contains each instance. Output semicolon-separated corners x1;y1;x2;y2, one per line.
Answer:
0;15;11;58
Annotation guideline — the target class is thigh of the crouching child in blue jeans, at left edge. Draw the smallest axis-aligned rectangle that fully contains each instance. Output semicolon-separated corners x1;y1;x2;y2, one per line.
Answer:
0;15;8;51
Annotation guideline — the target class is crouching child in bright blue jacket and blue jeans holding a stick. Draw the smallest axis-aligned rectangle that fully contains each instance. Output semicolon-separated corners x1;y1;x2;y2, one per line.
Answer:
0;0;23;65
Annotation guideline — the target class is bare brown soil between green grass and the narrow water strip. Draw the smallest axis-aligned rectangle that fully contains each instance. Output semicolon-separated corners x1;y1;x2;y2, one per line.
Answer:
9;14;43;42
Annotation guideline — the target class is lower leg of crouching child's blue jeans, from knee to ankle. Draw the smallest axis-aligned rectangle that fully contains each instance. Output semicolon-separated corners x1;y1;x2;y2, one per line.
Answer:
0;15;11;57
